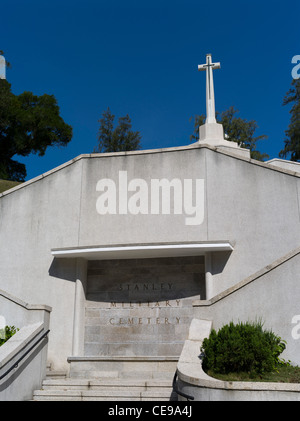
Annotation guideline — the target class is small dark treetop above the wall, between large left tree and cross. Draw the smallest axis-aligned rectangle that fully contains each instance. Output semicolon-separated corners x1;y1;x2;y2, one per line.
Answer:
94;108;141;152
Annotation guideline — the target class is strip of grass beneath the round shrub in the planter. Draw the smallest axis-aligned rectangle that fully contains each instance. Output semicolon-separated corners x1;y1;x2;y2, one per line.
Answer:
206;363;300;383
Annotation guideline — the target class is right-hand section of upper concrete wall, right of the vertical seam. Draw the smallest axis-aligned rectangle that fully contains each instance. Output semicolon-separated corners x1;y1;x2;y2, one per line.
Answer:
206;151;300;295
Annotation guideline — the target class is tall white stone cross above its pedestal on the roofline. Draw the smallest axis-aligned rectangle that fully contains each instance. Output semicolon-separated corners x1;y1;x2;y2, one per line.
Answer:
198;54;221;123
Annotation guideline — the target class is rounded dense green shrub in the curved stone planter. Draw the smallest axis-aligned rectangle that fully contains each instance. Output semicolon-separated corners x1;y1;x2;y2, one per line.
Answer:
201;322;286;374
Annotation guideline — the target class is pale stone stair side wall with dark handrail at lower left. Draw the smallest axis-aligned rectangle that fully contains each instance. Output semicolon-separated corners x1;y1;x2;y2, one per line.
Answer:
0;290;51;401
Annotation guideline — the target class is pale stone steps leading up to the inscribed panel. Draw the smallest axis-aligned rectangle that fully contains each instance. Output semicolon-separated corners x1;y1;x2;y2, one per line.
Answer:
33;357;177;401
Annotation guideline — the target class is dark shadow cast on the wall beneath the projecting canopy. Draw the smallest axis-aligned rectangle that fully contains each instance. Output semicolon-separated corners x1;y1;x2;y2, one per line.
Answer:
49;251;231;302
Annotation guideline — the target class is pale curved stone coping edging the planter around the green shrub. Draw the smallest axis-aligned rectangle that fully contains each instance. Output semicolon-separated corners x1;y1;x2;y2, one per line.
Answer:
177;319;300;399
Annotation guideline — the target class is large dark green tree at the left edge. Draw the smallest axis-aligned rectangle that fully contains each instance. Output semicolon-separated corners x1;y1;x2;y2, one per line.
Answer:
0;79;72;181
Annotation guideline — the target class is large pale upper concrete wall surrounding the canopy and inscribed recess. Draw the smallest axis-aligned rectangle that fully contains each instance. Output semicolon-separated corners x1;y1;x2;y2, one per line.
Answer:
0;146;300;369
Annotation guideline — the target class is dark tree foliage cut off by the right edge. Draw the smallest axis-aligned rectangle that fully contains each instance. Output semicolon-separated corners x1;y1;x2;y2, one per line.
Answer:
279;79;300;161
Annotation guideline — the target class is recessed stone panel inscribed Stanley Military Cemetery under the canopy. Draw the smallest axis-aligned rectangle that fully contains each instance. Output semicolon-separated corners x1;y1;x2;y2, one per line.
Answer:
85;256;205;356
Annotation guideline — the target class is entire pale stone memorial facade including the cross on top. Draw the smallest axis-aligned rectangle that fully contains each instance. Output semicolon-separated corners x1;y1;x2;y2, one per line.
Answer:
0;53;300;370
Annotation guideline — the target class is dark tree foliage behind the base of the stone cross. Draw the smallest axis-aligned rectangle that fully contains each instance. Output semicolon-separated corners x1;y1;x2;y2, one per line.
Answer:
190;107;269;161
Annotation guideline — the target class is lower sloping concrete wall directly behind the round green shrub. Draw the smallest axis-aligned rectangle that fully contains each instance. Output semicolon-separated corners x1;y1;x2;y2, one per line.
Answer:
194;248;300;365
